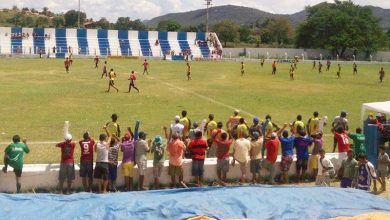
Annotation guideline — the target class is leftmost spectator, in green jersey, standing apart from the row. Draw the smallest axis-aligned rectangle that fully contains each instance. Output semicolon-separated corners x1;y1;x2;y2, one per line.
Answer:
3;135;30;193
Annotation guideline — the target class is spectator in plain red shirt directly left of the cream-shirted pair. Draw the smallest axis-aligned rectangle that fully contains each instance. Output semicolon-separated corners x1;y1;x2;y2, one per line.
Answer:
213;129;233;185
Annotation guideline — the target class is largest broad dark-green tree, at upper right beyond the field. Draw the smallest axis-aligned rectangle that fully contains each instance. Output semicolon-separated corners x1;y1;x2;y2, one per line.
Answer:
296;1;383;57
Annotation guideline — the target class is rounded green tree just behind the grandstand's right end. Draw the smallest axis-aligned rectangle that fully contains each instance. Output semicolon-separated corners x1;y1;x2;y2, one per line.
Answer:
212;20;240;47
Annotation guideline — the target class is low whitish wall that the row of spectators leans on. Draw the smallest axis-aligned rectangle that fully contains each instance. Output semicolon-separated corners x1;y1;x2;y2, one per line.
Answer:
0;153;346;192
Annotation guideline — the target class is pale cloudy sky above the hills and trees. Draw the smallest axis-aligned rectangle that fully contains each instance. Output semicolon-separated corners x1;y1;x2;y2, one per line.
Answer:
0;0;390;22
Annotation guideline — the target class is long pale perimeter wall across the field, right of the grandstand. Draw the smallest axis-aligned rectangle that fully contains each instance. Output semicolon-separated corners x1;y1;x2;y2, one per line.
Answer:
223;48;390;62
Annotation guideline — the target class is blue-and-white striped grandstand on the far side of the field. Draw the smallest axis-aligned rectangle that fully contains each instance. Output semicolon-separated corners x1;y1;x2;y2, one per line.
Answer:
0;27;222;59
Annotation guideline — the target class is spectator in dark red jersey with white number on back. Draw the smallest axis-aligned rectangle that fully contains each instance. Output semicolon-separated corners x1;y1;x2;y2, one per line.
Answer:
79;132;95;192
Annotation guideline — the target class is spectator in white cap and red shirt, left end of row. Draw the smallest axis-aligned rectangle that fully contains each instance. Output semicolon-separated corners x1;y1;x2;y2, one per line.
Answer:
56;134;76;193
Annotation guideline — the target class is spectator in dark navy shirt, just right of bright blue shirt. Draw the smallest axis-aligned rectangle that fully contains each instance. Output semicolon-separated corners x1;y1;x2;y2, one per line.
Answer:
294;131;313;182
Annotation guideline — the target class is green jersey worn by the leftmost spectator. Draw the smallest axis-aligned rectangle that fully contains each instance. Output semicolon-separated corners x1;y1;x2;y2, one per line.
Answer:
4;143;30;170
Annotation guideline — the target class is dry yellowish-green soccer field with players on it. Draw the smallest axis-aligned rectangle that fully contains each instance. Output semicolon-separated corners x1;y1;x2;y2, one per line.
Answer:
0;56;390;163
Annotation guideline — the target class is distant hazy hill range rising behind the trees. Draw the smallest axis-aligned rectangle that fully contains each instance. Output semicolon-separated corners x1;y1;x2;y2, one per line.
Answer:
145;5;390;29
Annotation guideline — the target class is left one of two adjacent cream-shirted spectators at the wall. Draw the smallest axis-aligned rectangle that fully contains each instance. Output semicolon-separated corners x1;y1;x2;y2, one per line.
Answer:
232;130;251;183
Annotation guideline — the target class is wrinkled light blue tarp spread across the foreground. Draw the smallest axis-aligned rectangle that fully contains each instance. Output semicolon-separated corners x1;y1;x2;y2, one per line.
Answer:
0;186;390;220
